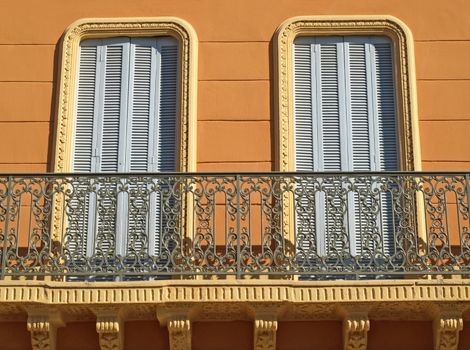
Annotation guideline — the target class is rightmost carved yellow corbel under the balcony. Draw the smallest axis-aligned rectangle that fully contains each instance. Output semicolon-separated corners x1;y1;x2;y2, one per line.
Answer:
433;305;463;350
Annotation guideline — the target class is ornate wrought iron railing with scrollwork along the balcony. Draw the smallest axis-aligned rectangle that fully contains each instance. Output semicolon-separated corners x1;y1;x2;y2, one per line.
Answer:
0;173;470;280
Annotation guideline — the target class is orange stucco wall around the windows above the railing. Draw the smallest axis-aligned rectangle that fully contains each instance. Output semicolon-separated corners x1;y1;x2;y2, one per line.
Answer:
0;0;470;172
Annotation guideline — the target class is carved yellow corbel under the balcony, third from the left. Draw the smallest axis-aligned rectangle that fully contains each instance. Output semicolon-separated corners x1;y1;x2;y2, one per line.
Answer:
157;304;192;350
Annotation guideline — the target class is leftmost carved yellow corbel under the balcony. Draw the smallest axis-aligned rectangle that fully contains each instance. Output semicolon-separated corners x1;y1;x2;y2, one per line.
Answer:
27;308;64;350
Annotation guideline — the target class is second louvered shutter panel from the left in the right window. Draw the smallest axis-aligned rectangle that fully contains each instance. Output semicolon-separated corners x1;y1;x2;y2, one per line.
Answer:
317;38;348;255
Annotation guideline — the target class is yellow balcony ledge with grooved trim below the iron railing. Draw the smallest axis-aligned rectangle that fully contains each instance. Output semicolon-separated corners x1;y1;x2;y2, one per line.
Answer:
0;280;470;324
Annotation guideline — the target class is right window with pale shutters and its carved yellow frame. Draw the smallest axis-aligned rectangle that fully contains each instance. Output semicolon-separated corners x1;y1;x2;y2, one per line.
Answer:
276;16;420;255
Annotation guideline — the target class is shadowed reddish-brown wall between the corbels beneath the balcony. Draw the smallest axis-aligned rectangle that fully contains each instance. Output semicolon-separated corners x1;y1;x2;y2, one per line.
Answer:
0;320;448;350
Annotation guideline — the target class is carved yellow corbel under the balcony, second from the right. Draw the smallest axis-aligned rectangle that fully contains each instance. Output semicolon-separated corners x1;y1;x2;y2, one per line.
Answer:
340;305;370;350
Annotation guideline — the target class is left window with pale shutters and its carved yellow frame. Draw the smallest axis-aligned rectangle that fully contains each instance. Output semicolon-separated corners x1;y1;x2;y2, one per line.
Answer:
54;18;197;266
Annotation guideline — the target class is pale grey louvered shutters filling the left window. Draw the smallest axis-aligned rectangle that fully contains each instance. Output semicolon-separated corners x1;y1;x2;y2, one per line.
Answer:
71;38;178;262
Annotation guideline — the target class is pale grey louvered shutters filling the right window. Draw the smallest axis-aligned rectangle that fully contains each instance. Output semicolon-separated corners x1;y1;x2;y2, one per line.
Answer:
294;37;399;254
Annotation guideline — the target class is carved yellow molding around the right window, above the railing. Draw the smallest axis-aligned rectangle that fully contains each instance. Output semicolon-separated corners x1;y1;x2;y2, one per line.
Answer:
274;16;421;171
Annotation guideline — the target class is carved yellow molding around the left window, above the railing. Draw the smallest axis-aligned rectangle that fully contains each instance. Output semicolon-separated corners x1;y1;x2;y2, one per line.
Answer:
54;17;198;172
